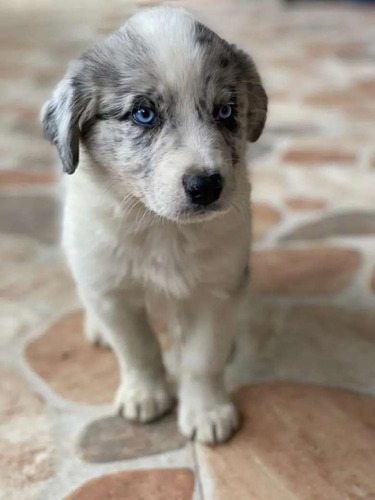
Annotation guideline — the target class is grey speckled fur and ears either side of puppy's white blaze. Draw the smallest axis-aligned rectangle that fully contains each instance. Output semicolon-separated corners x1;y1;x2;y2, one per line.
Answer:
43;7;267;182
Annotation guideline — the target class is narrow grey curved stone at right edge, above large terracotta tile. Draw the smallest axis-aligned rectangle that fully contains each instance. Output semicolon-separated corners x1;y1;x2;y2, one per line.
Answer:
281;211;375;241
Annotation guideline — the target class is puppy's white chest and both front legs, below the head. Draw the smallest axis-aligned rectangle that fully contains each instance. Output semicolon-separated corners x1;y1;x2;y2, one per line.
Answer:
63;149;250;443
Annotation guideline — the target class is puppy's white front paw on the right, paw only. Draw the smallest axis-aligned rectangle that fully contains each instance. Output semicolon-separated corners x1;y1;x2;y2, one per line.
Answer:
178;401;239;444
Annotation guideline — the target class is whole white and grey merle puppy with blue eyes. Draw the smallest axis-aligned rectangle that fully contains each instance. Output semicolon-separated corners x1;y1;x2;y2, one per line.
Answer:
42;7;267;443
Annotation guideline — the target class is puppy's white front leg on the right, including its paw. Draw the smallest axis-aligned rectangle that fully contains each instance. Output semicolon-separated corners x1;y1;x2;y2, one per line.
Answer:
178;299;239;444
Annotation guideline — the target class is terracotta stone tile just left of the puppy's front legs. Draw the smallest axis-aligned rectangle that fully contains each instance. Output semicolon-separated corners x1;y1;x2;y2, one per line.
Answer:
26;312;119;404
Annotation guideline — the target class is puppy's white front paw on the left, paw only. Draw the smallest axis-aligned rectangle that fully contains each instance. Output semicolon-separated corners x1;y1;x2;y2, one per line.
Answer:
115;378;174;423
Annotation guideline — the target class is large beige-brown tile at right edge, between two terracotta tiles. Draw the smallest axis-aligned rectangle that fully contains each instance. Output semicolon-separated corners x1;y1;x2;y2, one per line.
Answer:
248;302;375;392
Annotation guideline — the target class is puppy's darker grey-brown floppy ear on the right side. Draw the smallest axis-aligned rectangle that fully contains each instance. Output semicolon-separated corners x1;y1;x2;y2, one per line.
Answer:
234;47;268;142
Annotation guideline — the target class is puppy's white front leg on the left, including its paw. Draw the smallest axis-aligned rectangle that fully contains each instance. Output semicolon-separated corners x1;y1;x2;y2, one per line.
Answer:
80;290;173;422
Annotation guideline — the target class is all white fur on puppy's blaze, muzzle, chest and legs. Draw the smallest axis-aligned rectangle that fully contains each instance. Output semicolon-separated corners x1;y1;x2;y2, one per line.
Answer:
43;8;266;443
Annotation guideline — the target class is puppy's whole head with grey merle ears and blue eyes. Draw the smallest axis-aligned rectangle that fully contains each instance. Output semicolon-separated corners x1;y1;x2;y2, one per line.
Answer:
42;7;267;220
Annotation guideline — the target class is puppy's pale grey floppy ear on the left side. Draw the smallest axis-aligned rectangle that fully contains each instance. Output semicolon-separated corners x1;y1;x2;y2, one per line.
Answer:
41;77;90;174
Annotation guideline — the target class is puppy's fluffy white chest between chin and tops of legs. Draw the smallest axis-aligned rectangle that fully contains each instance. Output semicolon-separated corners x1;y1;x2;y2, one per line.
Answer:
64;167;250;299
